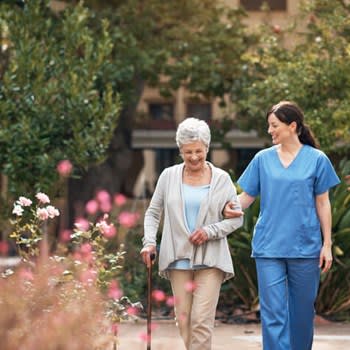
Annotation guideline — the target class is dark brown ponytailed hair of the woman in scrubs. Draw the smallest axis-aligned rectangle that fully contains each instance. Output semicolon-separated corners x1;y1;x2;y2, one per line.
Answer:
266;101;318;148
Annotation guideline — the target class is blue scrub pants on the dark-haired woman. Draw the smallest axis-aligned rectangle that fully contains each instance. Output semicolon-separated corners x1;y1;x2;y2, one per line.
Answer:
255;258;320;350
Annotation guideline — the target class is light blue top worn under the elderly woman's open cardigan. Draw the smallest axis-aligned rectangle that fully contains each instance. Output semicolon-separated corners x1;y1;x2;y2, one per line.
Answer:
169;184;210;270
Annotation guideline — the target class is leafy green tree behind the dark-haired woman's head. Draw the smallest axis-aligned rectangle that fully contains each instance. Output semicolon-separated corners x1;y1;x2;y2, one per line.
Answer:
232;0;350;153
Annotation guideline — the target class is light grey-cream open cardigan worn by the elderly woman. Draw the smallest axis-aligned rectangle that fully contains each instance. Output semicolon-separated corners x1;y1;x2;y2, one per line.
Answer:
143;162;243;281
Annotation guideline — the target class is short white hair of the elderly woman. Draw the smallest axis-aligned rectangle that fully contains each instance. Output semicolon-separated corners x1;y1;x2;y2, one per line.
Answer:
176;118;211;148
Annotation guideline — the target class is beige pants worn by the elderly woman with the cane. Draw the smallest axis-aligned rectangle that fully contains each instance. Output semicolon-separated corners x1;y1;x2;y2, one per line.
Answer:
170;268;224;350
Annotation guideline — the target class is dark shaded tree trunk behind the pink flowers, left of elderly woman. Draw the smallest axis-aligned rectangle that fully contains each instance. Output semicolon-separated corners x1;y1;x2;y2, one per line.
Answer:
64;80;144;228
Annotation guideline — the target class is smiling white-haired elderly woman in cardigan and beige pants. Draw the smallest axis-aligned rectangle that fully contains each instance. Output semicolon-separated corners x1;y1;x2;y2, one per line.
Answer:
141;118;243;350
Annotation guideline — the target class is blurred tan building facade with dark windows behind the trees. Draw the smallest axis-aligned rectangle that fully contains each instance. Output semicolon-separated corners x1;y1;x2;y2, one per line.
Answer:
132;0;300;197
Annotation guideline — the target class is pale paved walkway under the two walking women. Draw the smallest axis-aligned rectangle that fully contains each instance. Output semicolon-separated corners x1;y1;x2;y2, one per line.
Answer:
118;320;350;350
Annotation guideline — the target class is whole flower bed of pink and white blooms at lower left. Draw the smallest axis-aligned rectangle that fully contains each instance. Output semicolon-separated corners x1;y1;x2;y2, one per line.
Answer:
0;191;142;350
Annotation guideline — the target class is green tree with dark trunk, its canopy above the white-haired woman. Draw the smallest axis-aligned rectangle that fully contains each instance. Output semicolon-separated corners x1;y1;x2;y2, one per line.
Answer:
63;0;255;223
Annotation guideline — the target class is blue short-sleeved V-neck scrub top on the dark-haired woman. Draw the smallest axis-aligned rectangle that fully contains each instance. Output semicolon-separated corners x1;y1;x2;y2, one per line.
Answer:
238;145;340;258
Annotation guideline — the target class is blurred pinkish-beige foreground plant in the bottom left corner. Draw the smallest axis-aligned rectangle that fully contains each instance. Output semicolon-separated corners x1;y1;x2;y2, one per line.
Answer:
0;261;113;350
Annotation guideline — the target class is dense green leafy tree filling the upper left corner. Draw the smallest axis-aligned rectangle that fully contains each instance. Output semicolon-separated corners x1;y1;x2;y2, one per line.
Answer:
0;0;121;195
